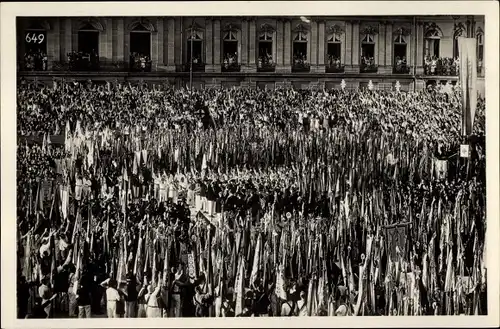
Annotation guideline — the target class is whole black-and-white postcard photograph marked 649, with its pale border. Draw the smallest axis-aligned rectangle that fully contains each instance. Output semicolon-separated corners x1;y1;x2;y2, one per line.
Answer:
2;2;498;326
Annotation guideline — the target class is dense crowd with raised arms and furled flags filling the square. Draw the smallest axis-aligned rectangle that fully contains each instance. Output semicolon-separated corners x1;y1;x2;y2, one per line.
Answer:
17;83;487;318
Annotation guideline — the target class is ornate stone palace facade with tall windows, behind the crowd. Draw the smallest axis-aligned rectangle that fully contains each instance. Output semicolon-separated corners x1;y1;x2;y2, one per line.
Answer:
17;16;485;94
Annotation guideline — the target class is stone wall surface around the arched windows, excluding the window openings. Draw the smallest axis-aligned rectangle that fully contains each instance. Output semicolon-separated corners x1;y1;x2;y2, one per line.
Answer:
17;16;486;93
